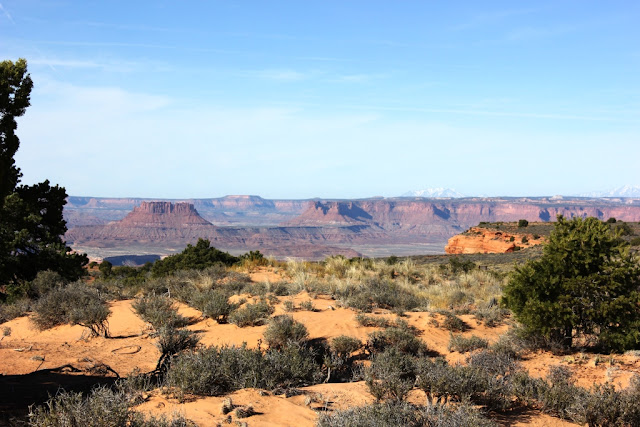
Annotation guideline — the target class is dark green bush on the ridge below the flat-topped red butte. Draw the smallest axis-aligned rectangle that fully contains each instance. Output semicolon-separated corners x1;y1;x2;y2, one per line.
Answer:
151;239;239;277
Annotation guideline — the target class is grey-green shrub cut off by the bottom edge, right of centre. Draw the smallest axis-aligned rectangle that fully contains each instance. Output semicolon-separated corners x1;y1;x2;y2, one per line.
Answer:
318;401;496;427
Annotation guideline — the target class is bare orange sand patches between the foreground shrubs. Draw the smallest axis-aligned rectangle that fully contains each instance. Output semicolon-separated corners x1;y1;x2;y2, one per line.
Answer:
0;271;640;427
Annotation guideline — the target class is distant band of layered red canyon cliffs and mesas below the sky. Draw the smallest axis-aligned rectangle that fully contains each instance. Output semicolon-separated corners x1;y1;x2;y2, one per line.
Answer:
65;196;640;256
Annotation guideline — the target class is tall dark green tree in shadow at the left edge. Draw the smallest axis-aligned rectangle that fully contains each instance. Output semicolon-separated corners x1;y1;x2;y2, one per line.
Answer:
0;59;88;292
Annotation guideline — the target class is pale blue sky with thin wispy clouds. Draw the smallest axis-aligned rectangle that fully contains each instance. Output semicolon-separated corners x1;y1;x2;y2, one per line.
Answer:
0;0;640;198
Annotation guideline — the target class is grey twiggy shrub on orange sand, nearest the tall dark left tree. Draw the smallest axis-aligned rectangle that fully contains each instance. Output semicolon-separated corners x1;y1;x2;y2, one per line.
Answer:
32;283;109;336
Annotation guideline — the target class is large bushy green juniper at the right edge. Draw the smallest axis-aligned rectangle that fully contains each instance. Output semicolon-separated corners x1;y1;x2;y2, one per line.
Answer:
503;216;640;350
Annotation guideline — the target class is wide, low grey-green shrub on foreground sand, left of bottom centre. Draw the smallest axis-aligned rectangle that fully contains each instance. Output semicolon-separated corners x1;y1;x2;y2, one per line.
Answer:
166;345;322;396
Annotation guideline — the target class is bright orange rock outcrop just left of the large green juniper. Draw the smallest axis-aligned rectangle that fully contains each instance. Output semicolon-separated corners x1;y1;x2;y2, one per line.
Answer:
444;227;545;254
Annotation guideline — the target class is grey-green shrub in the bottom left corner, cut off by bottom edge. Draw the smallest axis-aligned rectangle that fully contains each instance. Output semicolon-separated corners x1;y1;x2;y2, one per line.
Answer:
29;387;195;427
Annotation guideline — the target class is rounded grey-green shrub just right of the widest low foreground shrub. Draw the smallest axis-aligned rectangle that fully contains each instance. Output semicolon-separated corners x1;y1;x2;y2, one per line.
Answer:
365;347;416;400
